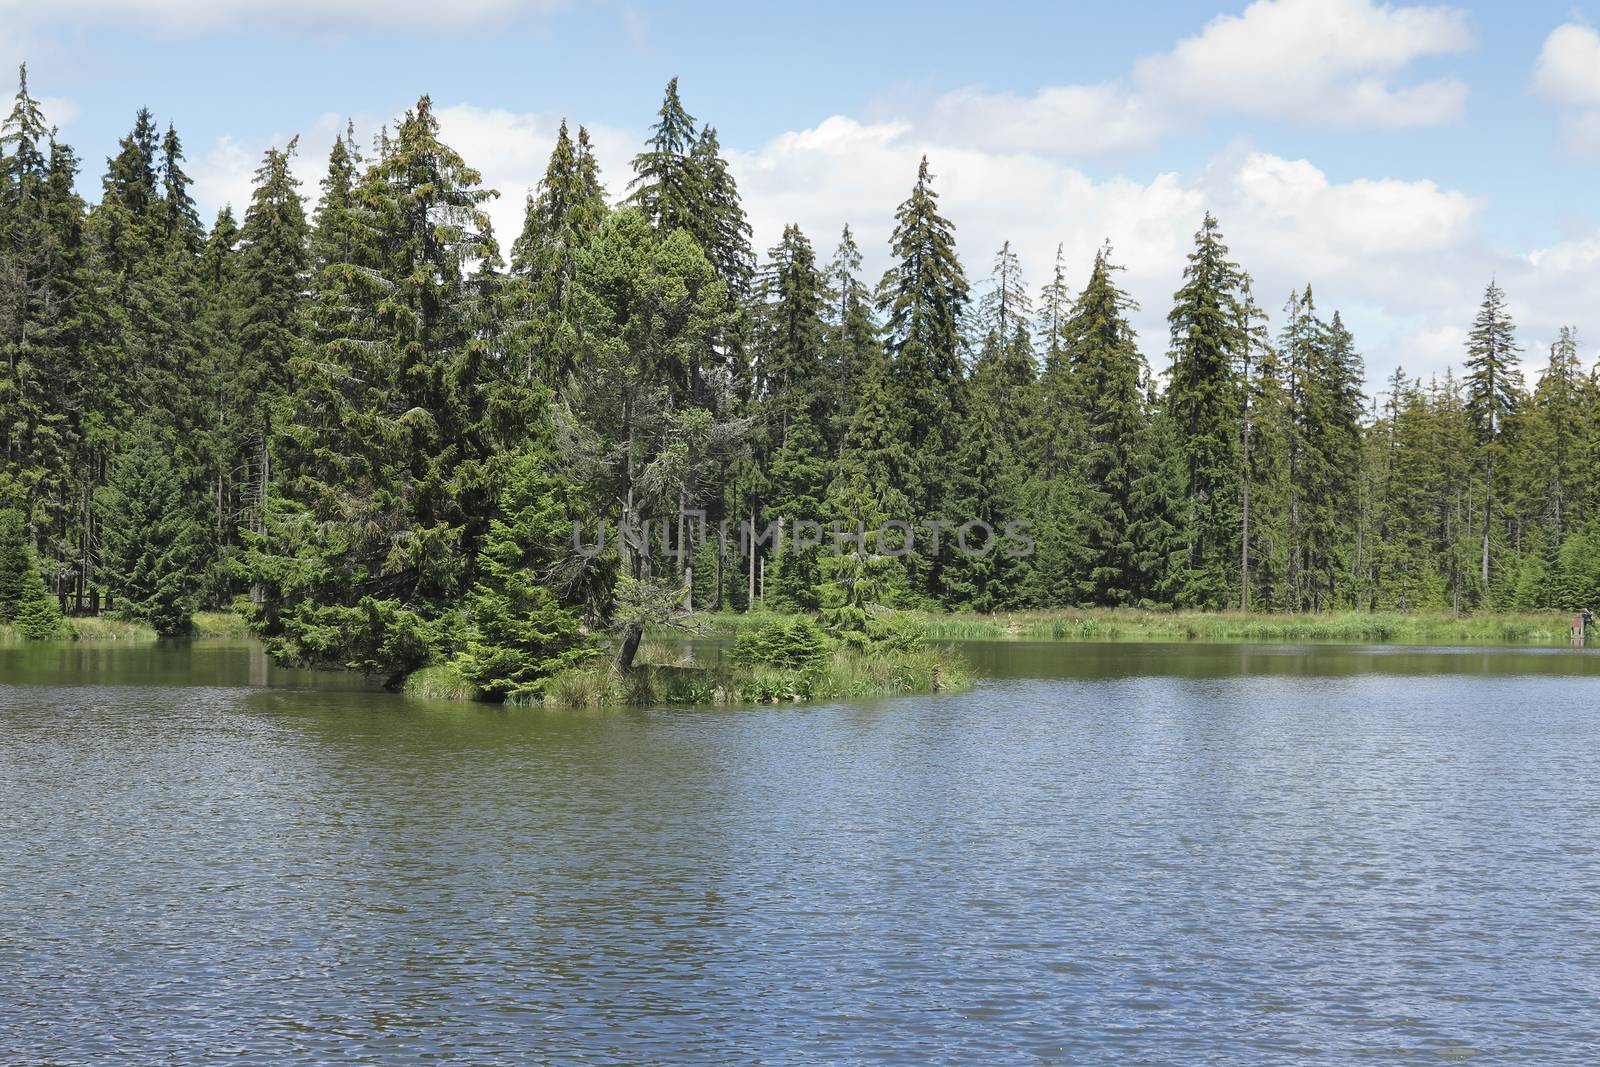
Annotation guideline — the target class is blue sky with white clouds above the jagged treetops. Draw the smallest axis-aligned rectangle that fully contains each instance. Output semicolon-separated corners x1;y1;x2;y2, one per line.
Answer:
0;0;1600;390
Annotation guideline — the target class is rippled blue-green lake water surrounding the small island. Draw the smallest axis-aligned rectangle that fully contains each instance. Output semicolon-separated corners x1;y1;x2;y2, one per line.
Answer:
0;645;1600;1065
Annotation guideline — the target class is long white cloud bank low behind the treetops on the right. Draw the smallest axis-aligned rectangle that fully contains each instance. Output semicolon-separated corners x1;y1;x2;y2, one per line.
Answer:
733;115;1600;389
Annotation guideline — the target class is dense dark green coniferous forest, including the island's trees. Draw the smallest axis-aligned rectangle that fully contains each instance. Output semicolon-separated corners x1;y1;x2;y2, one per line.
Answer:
0;70;1600;696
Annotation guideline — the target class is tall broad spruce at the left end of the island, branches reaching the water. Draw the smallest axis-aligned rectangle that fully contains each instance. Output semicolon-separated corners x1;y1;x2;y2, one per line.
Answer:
248;96;505;685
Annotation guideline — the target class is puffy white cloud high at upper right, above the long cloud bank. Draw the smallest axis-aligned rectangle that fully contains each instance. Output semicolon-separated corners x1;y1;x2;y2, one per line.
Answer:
926;0;1472;155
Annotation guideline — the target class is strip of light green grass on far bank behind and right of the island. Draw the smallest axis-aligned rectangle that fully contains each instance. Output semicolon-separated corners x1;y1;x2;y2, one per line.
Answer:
672;608;1570;646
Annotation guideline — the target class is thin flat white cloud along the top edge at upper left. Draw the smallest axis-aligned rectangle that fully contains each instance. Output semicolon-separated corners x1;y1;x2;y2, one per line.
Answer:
0;0;563;34
